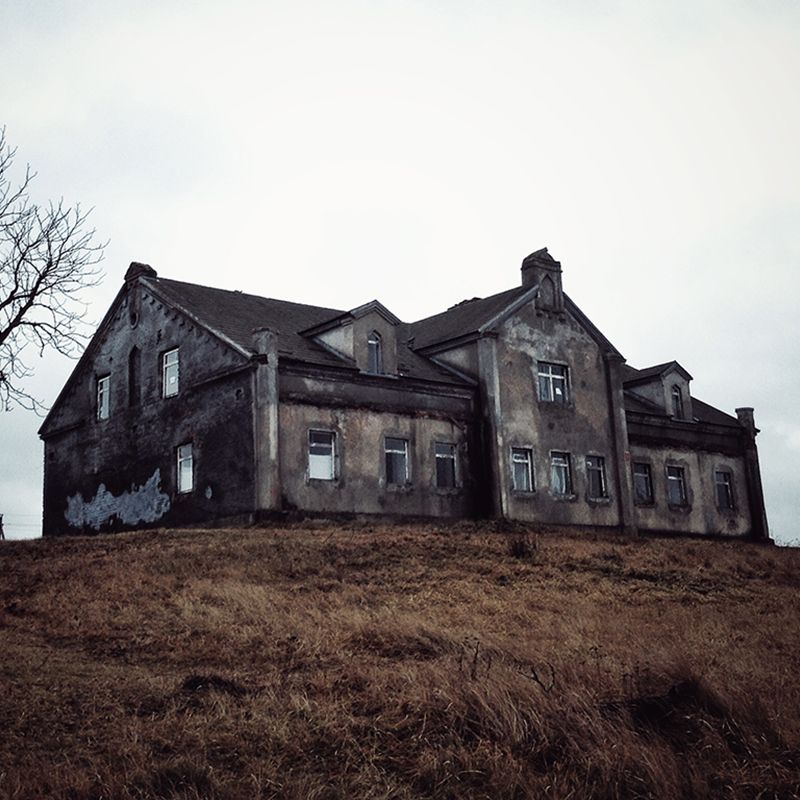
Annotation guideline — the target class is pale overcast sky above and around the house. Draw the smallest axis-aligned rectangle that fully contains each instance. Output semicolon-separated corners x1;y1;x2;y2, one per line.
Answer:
0;0;800;541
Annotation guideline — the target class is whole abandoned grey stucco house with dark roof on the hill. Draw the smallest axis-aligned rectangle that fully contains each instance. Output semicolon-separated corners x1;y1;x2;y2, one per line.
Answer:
40;249;769;539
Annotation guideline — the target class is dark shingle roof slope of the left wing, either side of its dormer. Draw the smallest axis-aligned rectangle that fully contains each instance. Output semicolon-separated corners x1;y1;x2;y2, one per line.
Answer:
147;278;461;383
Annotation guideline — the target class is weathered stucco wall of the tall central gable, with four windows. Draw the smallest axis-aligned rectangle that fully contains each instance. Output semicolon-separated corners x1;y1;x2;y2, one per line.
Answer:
496;303;620;526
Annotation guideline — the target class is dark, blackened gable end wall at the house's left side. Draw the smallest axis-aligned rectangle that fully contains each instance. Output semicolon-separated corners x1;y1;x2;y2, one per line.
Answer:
44;282;253;535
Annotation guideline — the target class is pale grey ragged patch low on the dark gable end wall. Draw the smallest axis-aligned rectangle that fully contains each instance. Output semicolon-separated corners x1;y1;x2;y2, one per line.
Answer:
64;469;170;531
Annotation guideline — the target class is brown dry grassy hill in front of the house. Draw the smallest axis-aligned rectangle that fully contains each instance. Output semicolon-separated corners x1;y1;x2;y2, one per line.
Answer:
0;524;800;800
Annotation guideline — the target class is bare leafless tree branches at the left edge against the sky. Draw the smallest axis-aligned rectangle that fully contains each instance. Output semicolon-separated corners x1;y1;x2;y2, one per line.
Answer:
0;128;105;412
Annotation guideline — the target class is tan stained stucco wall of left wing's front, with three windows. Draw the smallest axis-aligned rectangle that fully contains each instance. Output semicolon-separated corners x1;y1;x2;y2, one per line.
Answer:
280;402;471;517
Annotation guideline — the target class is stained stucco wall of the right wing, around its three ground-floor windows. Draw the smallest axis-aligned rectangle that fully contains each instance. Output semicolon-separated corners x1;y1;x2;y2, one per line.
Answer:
631;444;751;536
